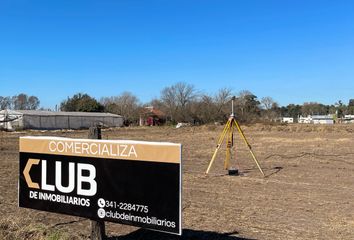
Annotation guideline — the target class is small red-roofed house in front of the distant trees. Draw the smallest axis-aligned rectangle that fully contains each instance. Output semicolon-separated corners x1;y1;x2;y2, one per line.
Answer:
139;106;166;126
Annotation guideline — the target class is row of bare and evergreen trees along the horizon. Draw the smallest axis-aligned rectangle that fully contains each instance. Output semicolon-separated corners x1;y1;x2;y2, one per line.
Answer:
0;82;354;124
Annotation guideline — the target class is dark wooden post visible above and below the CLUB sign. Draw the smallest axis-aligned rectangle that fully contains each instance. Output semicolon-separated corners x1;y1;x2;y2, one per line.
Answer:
88;125;106;240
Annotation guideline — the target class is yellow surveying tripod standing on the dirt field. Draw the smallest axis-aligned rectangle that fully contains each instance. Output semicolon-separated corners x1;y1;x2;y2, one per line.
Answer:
206;97;265;177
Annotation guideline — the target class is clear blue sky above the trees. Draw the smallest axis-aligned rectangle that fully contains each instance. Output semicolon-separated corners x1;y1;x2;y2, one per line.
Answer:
0;0;354;108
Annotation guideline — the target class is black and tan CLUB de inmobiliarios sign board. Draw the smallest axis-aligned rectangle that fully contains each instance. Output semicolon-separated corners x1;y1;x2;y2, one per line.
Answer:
19;137;182;235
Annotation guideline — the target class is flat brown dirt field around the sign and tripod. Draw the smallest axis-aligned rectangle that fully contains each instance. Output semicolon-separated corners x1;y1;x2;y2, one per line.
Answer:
0;125;354;240
